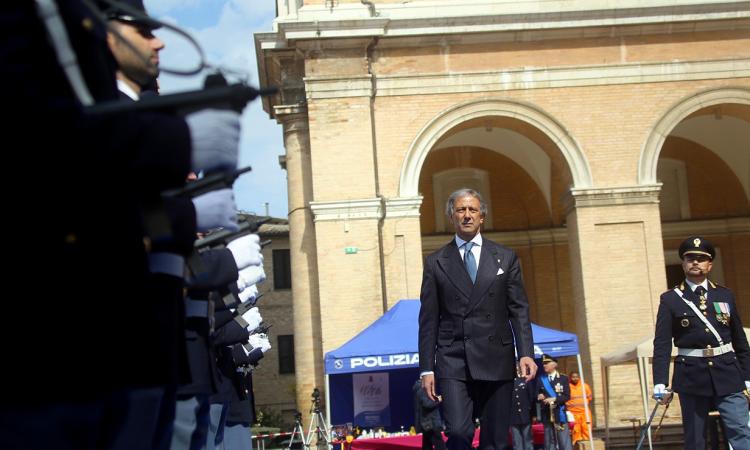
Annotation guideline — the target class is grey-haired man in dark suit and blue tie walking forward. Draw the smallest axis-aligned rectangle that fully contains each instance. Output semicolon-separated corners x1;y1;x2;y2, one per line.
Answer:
419;189;536;450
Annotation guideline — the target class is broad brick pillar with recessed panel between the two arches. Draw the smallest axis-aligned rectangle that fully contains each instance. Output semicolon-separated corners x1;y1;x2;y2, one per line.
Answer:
567;184;666;426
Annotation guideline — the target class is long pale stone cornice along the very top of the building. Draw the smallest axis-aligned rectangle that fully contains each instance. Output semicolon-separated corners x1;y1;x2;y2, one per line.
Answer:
270;0;750;42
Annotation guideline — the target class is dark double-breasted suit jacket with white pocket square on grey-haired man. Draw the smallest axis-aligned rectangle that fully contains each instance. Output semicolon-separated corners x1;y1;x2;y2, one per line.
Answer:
419;237;533;381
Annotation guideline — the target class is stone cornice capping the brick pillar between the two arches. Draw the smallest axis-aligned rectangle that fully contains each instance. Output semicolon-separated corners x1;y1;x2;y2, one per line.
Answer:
563;183;661;212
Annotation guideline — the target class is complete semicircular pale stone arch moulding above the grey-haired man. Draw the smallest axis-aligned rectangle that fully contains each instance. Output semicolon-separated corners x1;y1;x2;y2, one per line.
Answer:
399;99;593;197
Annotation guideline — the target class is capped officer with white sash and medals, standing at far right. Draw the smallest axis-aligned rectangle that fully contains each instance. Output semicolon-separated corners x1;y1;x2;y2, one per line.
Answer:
653;236;750;450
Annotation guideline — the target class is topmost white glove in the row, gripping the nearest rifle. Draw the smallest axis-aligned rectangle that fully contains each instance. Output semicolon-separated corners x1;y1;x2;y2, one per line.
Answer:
185;109;240;172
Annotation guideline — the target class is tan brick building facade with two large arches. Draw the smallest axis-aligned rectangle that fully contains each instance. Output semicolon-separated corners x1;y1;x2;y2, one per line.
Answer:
255;0;750;428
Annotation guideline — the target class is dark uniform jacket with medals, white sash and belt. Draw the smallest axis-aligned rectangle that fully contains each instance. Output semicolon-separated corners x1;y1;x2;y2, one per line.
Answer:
653;282;750;396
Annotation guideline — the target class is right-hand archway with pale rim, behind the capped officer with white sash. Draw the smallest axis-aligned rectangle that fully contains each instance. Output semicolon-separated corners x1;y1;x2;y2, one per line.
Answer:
640;89;750;321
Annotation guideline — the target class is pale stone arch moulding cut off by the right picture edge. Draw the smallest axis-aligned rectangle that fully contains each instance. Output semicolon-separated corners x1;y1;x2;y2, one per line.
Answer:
638;88;750;185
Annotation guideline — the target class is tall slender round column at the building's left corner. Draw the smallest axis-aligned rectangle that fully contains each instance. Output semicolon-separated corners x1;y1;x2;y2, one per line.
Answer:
274;105;325;423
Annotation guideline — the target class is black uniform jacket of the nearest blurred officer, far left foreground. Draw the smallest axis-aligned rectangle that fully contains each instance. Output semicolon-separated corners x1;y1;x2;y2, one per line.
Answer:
0;0;191;402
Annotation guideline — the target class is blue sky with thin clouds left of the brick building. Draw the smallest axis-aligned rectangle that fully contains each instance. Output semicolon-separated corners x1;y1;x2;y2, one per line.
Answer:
144;0;288;218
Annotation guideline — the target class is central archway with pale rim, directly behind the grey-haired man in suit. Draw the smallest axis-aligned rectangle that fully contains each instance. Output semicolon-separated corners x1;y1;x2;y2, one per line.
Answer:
402;101;591;332
